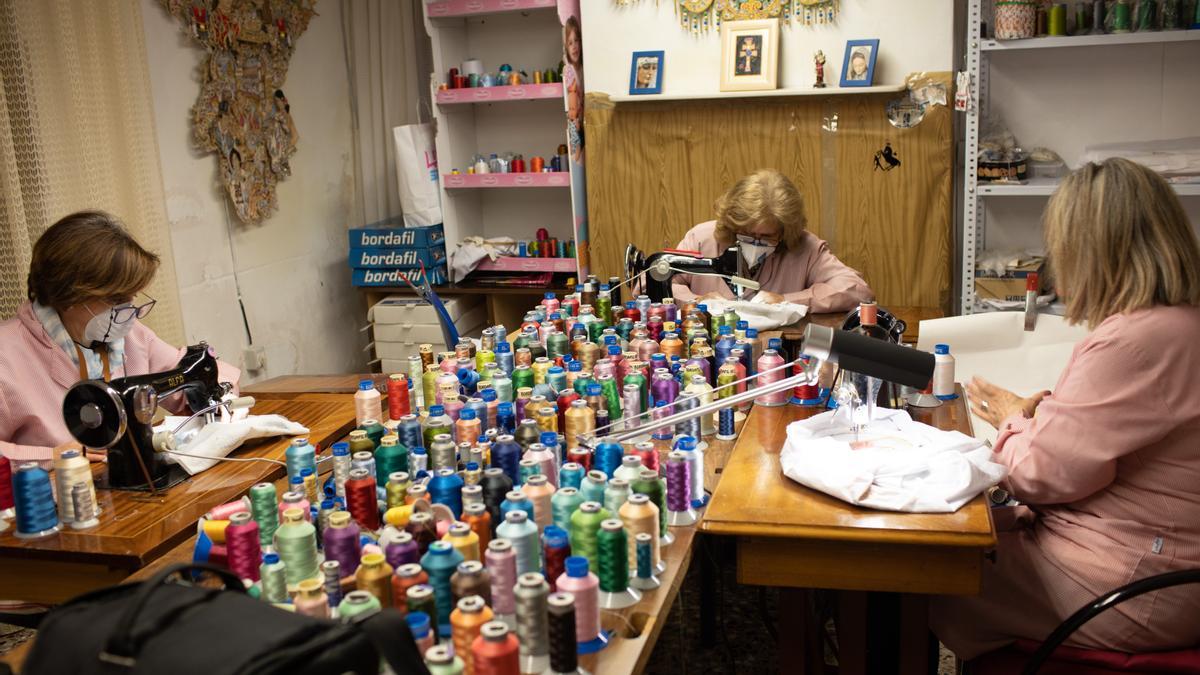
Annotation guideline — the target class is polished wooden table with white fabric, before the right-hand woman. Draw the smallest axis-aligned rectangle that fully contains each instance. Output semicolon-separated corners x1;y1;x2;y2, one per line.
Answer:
700;388;996;673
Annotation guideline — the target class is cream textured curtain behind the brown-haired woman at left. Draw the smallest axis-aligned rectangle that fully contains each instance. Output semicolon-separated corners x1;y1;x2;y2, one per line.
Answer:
0;0;184;345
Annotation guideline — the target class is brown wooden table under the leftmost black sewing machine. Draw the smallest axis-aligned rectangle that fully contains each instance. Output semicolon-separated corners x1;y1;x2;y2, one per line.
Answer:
0;399;354;604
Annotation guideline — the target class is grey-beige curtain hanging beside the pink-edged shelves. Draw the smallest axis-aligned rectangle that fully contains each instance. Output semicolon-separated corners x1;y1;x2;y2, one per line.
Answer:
342;0;432;226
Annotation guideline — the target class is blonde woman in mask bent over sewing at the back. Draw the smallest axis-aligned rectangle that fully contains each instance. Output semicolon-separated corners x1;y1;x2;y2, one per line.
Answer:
672;169;875;312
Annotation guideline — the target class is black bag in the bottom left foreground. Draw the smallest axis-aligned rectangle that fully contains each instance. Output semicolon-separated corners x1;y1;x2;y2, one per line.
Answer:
22;565;428;675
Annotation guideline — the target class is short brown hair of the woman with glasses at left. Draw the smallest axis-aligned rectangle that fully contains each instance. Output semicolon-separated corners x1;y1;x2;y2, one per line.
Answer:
28;211;158;310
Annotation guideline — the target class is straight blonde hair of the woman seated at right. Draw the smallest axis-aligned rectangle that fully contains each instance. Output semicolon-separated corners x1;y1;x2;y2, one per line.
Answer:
1043;157;1200;328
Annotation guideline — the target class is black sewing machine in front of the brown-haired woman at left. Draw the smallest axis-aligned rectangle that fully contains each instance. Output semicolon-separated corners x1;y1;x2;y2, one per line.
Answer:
62;342;233;490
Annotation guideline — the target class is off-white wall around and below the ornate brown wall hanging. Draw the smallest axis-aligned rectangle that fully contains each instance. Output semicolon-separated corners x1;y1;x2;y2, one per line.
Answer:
142;0;366;382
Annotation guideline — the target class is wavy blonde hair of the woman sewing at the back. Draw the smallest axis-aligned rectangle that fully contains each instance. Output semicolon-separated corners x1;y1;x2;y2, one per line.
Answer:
714;169;808;250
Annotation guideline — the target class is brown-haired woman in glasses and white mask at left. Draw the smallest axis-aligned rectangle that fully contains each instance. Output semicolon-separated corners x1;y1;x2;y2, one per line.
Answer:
0;211;239;461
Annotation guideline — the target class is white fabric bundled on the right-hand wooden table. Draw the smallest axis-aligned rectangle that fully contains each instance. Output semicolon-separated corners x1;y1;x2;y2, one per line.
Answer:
779;408;1007;513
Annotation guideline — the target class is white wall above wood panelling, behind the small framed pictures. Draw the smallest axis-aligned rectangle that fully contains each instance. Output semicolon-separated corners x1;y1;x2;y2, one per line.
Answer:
581;0;954;95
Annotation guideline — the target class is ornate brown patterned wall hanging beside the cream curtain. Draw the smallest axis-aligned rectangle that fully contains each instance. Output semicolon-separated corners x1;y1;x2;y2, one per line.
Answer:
158;0;316;223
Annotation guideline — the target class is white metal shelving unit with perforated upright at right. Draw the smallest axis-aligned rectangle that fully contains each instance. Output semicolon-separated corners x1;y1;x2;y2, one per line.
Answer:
959;0;1200;315
